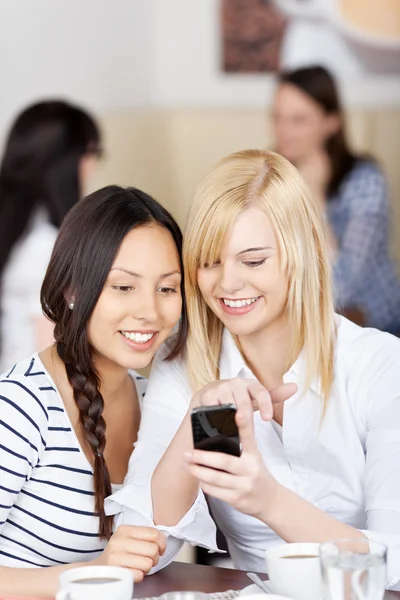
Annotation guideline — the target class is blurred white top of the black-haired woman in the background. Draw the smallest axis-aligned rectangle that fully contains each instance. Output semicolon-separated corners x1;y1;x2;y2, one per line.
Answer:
0;210;58;373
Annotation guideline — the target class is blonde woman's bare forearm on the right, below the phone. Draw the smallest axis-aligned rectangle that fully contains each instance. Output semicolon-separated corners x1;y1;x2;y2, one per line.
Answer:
260;483;365;542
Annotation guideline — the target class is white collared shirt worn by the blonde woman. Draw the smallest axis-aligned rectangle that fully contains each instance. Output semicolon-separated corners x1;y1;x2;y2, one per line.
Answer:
107;317;400;586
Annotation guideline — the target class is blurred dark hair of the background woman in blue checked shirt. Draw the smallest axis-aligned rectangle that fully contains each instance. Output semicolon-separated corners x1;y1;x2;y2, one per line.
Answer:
279;66;359;197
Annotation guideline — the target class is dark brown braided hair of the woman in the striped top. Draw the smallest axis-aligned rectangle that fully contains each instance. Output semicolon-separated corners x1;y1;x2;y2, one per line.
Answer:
41;186;188;539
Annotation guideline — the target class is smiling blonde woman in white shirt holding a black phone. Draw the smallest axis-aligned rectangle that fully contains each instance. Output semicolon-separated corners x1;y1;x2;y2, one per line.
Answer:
109;150;400;586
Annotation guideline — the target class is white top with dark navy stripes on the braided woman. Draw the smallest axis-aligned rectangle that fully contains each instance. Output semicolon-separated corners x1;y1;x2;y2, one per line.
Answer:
0;354;145;567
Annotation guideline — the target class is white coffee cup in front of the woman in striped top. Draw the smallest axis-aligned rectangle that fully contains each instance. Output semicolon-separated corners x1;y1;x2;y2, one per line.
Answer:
56;565;133;600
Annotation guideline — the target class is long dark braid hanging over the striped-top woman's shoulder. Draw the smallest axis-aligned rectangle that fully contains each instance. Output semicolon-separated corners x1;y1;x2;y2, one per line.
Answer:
57;342;113;540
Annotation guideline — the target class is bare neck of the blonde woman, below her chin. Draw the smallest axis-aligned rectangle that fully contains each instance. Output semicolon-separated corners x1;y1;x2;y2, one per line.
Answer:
239;318;290;389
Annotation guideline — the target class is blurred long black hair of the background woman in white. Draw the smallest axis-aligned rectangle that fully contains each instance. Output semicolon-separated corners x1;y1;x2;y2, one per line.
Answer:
0;101;100;277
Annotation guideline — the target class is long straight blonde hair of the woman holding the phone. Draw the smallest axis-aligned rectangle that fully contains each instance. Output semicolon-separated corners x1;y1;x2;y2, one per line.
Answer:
183;150;335;401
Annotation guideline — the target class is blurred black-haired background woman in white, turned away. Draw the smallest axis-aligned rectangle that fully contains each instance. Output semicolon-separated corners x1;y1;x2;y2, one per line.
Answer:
0;101;100;372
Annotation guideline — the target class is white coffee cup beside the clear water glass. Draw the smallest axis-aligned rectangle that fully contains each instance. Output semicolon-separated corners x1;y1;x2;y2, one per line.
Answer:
265;543;323;600
